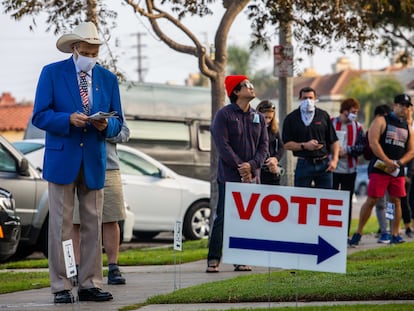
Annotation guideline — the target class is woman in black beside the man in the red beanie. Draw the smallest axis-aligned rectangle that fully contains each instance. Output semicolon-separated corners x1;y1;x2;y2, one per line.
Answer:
256;100;285;185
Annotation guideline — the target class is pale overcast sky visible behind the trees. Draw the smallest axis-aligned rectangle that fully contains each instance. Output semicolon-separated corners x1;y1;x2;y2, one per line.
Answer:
0;0;388;101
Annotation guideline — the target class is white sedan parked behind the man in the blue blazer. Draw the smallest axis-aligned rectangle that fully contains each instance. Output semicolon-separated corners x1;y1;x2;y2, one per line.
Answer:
14;139;210;240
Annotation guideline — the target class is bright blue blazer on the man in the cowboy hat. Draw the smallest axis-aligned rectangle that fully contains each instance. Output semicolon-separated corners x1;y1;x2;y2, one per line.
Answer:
32;57;123;189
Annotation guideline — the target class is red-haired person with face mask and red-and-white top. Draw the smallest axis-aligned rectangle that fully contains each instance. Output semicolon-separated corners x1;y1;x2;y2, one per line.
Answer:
332;98;366;239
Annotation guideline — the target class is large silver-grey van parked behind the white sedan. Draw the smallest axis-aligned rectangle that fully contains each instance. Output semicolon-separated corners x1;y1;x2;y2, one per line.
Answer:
118;81;211;181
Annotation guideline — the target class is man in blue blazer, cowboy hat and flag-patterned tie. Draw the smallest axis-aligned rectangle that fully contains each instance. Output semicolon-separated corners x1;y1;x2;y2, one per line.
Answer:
32;22;123;303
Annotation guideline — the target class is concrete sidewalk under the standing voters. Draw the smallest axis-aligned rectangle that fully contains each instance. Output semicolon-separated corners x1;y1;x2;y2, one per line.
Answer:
0;235;414;311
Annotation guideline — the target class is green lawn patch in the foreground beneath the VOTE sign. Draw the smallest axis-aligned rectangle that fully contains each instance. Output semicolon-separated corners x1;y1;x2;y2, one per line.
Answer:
140;243;414;310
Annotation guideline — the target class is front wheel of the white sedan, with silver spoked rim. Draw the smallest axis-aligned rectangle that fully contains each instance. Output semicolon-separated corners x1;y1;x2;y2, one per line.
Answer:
183;202;211;240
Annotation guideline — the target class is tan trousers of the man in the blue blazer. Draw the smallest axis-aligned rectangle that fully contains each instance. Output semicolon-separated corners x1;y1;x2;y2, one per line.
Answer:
48;170;103;293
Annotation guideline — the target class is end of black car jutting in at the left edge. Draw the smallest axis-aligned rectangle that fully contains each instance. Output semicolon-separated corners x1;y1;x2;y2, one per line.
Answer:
0;188;21;262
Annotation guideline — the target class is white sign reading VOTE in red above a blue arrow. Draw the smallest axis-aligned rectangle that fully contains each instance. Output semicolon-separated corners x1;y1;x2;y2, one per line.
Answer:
223;183;349;273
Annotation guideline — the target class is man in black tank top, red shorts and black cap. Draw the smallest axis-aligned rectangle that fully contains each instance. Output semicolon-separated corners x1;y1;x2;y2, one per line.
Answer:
349;94;414;247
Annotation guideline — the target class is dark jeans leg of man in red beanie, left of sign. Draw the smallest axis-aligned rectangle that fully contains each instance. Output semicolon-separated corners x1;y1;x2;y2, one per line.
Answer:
207;182;226;261
